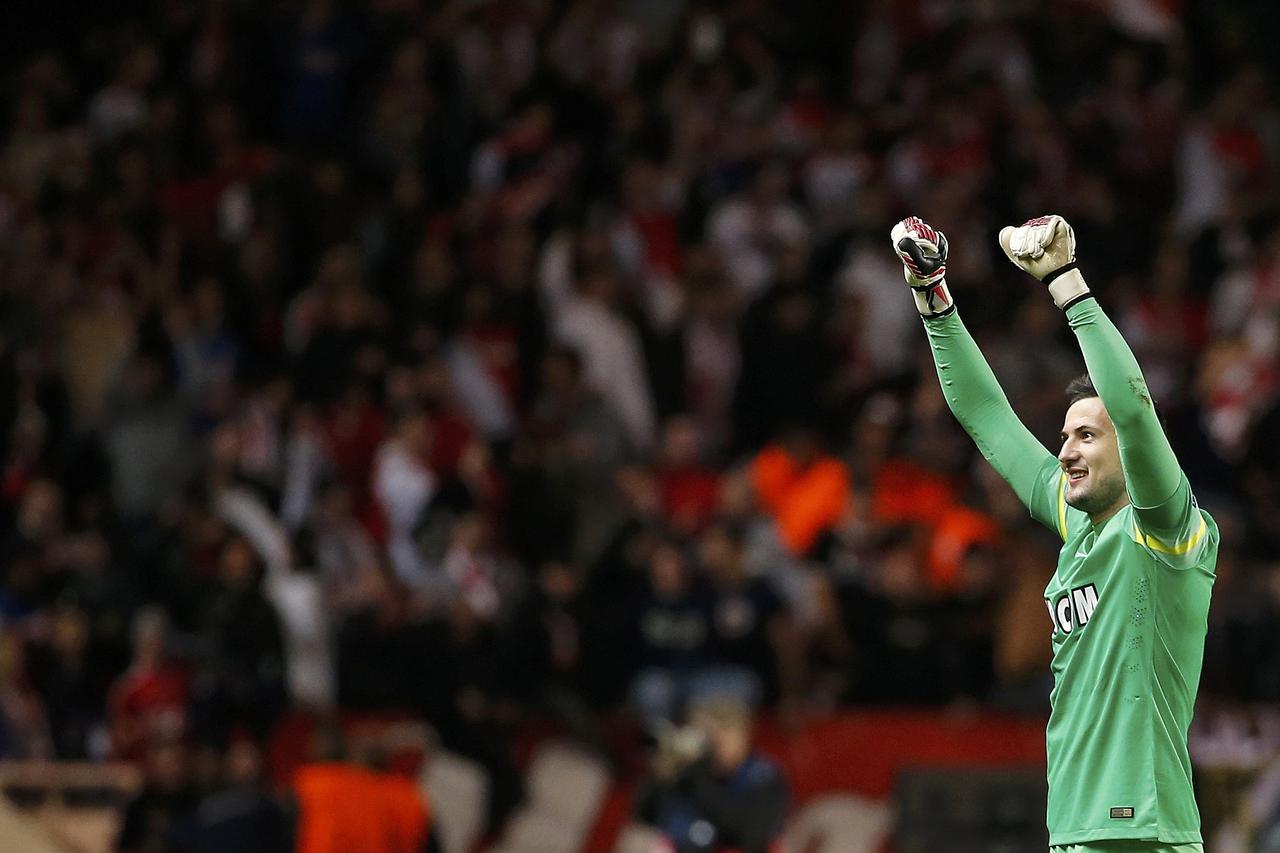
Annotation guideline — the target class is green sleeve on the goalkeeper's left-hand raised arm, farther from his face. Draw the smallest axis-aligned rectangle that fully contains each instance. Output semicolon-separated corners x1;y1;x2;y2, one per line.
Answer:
924;311;1066;539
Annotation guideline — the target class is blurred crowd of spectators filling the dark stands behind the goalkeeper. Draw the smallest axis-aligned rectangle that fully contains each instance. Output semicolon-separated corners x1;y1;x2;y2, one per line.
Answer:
0;0;1280;845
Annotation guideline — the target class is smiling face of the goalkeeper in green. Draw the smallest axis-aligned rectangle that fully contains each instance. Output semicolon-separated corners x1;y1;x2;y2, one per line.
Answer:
1057;397;1129;523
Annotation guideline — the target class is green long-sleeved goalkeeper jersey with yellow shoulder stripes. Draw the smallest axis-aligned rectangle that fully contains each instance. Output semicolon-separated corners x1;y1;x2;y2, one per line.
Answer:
925;298;1219;845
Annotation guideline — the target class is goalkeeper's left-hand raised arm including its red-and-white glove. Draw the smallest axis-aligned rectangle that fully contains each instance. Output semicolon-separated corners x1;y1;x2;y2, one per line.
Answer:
892;216;1066;539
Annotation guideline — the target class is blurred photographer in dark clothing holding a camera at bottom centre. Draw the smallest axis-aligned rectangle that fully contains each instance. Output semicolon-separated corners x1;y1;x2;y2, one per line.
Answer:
636;697;787;853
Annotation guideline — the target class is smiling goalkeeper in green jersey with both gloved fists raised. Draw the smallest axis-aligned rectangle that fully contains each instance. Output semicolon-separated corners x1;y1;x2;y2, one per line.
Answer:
892;216;1219;853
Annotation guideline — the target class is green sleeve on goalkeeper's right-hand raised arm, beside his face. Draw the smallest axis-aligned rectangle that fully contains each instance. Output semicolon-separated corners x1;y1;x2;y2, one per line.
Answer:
1066;298;1189;530
